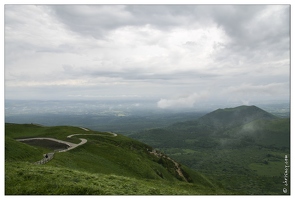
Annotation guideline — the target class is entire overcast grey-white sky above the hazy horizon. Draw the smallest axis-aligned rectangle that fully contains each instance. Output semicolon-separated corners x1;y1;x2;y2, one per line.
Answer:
4;5;290;108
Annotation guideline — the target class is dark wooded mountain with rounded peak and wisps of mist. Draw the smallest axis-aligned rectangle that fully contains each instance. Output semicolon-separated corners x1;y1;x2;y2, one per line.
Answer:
131;106;289;148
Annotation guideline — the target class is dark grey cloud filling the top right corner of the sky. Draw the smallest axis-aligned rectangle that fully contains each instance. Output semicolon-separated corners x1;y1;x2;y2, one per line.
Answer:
212;5;290;62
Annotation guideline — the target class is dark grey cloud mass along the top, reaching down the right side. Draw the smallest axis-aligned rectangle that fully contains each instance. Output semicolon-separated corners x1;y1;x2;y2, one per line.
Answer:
51;5;290;63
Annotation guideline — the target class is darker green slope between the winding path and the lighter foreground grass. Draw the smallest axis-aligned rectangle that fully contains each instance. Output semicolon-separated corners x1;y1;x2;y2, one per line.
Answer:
48;136;175;180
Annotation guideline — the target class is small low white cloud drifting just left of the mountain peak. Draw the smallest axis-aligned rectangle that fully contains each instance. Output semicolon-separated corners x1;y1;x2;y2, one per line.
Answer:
157;92;208;108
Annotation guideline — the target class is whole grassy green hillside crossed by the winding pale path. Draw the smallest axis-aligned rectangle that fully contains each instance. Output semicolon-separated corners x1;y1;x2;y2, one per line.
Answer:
5;124;225;194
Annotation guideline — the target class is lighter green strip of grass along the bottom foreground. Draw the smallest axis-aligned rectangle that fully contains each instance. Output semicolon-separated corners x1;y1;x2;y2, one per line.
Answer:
5;162;227;195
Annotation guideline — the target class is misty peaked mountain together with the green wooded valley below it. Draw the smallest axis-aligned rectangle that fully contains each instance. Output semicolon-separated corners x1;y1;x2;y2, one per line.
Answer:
131;106;290;194
